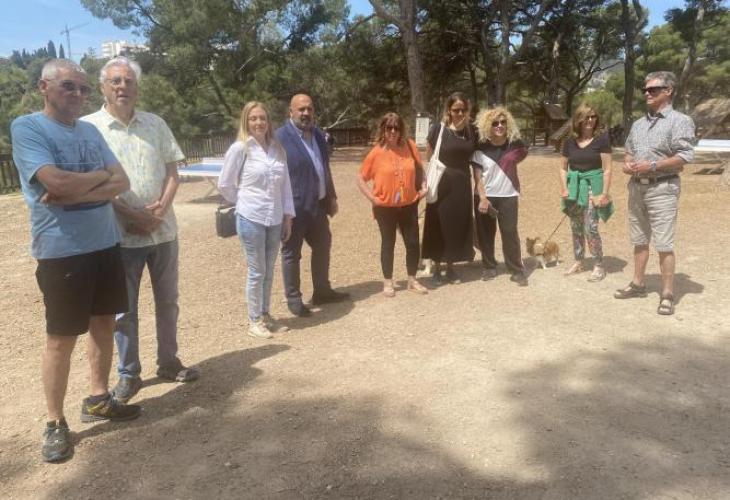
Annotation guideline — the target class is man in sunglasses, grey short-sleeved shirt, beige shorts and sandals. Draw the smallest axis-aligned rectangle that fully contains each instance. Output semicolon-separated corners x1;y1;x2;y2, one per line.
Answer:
614;71;694;315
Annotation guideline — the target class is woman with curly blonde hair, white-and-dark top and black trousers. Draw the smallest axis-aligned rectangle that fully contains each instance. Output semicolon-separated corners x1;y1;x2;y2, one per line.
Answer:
472;106;527;286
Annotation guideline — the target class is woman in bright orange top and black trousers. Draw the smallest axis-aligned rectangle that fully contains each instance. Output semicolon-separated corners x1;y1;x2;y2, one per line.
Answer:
357;113;426;297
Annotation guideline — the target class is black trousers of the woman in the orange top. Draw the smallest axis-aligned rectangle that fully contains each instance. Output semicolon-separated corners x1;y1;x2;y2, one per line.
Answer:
373;202;420;280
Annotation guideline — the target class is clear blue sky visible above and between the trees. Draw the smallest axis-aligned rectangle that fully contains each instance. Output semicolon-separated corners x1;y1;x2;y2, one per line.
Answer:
0;0;684;60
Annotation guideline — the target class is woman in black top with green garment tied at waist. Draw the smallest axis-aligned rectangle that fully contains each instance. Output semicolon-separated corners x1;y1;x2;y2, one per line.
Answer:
560;104;613;281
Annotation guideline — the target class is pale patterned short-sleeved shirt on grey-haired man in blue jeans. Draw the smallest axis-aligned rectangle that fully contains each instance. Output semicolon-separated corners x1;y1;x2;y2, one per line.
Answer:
81;107;185;248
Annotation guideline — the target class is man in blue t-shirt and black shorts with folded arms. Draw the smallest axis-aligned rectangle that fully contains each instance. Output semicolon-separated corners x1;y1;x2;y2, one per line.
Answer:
10;59;140;462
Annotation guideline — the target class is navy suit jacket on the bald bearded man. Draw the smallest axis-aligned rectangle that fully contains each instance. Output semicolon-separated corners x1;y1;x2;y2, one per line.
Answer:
276;120;337;221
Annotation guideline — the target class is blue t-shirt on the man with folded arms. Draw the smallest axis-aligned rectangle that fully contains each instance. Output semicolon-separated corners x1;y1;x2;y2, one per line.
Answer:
10;113;121;259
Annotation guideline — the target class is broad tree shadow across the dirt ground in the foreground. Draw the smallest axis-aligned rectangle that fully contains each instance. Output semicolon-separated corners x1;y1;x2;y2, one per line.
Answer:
38;336;730;500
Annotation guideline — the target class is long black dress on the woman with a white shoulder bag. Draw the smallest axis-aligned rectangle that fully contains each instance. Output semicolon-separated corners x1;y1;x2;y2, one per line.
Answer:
422;123;477;262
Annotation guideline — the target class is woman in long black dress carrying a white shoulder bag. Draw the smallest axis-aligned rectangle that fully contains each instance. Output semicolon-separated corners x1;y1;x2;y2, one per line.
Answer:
422;92;477;285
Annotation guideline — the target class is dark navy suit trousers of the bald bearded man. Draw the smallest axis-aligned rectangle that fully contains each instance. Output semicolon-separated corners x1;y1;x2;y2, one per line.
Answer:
281;201;332;305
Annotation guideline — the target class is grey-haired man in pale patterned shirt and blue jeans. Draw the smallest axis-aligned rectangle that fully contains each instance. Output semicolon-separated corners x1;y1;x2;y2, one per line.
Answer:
82;57;199;402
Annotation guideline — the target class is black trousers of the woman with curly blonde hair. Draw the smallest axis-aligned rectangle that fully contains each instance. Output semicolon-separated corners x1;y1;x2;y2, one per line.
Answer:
474;196;524;273
